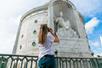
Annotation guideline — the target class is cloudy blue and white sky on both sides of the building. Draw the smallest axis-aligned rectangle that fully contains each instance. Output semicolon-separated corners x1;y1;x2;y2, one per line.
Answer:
0;0;102;55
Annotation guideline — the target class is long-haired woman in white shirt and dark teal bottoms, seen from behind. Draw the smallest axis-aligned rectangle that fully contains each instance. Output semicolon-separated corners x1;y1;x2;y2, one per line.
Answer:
38;24;59;68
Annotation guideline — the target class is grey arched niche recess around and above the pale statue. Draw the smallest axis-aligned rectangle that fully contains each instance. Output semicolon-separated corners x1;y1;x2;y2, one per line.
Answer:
49;0;79;37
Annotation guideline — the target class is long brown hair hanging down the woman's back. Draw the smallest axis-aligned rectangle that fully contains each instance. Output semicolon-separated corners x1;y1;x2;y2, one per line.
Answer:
38;24;48;44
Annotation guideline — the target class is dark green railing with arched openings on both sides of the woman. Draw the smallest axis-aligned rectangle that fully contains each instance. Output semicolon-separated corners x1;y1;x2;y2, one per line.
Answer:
0;54;102;68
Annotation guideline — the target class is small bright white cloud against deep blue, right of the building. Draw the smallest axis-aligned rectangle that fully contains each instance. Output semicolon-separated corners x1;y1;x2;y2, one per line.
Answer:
85;17;99;34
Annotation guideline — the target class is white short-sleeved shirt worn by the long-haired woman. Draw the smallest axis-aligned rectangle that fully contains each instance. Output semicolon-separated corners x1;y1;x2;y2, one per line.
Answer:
38;32;54;59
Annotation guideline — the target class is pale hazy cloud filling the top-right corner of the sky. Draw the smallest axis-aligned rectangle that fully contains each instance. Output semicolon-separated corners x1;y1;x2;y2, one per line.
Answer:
70;0;102;16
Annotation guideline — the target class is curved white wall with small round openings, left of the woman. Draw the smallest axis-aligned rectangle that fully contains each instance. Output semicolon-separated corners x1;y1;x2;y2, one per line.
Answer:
16;10;48;55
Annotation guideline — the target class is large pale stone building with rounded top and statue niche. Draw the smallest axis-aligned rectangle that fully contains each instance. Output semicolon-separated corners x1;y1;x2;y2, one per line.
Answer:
13;0;91;57
